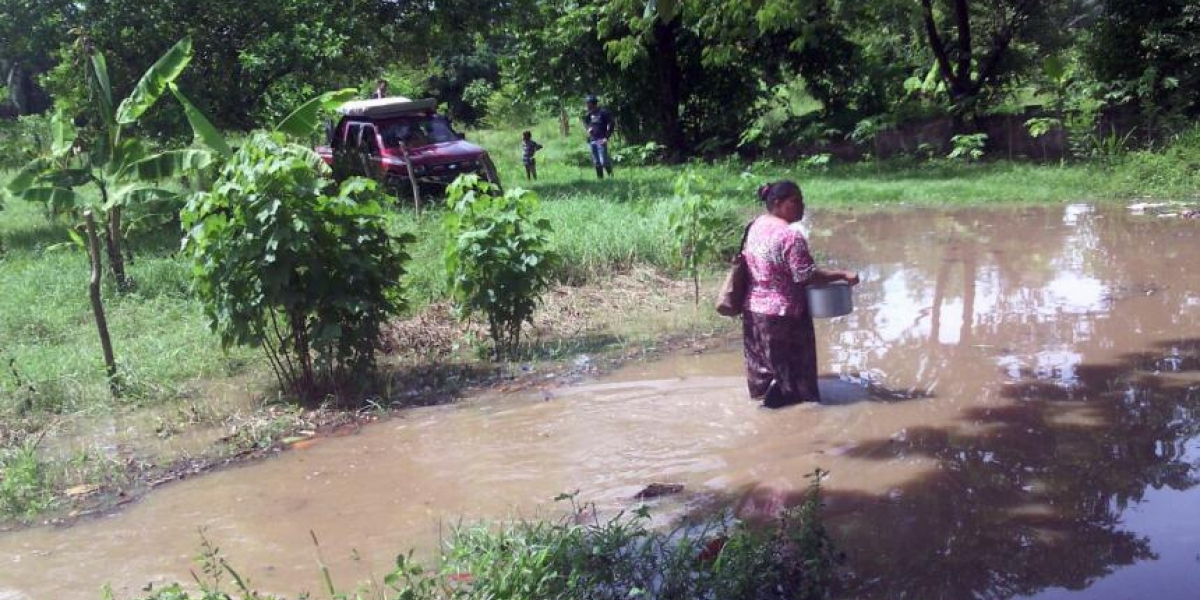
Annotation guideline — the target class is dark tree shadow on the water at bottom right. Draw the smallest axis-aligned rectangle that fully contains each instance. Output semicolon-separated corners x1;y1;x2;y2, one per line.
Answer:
700;338;1200;599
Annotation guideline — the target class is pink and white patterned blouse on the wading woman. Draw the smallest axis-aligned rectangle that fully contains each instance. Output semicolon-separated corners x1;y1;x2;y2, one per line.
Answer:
744;216;817;317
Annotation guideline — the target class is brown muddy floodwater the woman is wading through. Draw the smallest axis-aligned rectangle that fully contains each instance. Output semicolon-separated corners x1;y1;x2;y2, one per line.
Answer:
0;204;1200;600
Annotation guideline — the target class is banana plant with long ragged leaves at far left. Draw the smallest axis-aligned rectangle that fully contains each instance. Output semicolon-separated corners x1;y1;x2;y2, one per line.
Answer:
7;38;212;289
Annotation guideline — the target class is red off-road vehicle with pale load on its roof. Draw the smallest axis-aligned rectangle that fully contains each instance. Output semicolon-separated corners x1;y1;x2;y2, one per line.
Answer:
317;97;499;191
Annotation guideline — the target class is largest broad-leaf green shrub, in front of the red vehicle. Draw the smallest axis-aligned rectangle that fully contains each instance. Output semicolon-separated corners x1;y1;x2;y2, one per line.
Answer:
181;133;410;400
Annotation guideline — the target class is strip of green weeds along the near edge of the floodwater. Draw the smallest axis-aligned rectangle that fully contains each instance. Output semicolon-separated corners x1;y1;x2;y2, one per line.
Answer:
117;485;840;600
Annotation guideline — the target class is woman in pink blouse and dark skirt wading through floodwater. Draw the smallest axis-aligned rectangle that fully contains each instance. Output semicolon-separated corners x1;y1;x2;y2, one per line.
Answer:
742;180;858;408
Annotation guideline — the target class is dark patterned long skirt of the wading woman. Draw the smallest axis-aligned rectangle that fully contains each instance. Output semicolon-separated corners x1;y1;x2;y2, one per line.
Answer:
742;311;821;408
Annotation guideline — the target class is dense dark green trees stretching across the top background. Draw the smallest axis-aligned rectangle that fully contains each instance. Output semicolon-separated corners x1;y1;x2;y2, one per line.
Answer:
0;0;1200;160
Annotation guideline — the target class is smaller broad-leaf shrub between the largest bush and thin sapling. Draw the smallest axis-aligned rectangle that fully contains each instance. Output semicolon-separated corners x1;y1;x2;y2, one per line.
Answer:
444;175;556;358
